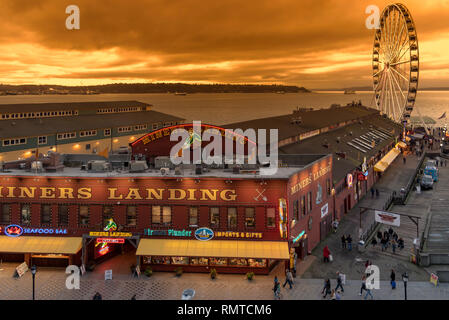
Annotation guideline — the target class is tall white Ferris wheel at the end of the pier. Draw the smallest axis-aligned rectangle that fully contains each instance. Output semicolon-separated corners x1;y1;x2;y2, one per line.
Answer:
373;3;419;123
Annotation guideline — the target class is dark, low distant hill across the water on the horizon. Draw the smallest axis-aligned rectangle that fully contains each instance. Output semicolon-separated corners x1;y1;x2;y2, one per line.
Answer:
0;83;310;95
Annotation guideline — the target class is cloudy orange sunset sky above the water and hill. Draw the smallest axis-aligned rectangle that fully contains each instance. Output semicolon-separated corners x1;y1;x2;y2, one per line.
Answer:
0;0;449;89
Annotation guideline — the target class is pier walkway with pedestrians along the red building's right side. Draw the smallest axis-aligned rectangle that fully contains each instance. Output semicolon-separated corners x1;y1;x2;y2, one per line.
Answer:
303;155;428;281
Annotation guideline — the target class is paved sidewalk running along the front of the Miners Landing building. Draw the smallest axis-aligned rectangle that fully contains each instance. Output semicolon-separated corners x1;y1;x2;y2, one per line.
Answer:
0;265;449;300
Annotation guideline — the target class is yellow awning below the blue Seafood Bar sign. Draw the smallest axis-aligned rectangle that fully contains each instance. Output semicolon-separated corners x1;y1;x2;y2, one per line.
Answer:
0;236;83;254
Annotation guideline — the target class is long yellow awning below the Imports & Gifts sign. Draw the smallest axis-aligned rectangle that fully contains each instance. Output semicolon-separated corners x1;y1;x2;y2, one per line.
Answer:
136;239;290;259
